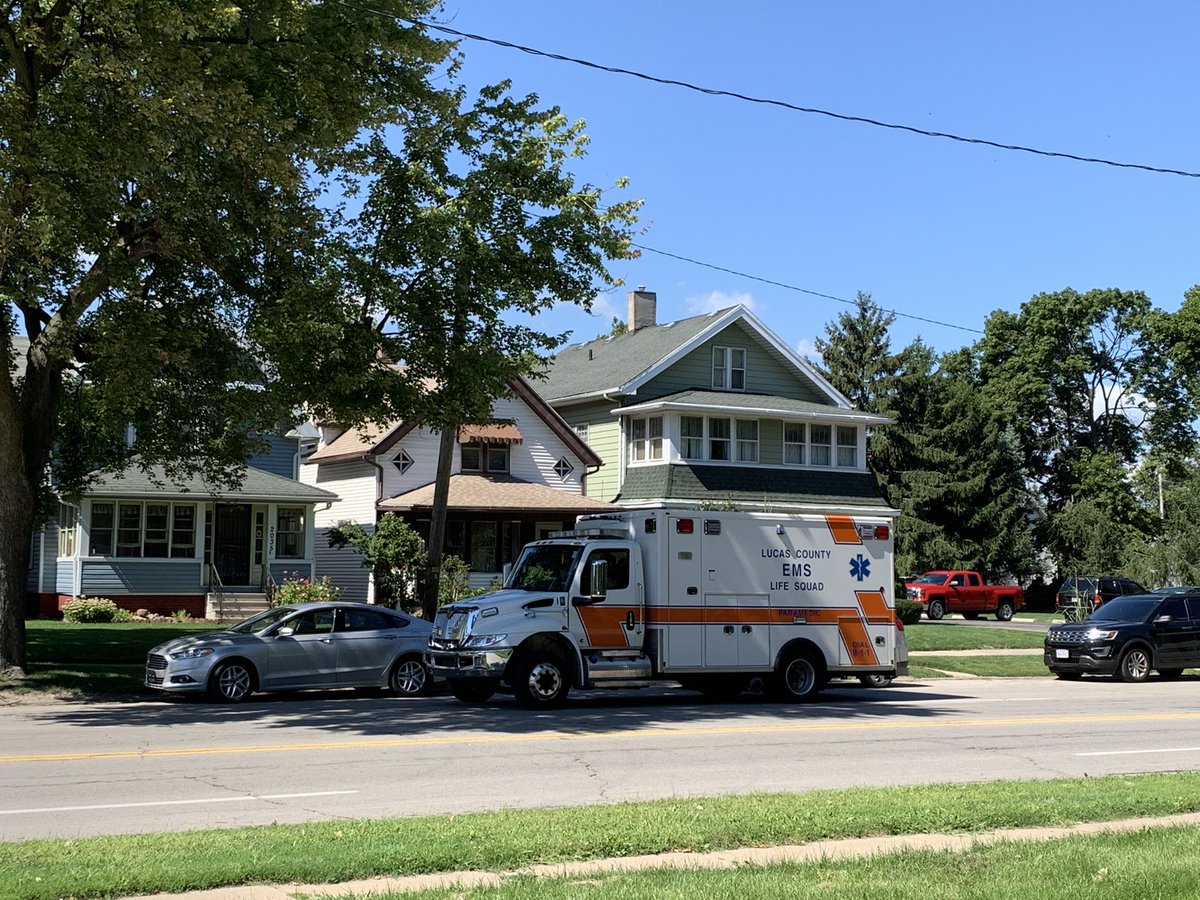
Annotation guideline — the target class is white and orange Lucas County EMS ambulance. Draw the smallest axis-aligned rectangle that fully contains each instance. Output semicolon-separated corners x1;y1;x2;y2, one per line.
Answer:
426;509;907;708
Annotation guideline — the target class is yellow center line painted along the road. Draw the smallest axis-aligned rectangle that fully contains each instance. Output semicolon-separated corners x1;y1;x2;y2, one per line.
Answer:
7;713;1200;763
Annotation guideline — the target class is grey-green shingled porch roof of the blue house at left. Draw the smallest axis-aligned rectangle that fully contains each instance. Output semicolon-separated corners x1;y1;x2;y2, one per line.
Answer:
84;463;338;503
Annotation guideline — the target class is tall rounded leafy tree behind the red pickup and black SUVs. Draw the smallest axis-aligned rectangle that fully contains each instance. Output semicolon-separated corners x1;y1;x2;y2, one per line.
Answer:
974;289;1196;565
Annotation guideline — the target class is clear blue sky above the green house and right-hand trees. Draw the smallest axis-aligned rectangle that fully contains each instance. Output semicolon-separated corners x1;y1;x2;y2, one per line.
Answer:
440;0;1200;362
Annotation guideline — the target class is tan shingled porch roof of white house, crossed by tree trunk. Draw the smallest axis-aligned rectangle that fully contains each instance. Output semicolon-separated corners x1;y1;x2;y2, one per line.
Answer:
379;475;617;514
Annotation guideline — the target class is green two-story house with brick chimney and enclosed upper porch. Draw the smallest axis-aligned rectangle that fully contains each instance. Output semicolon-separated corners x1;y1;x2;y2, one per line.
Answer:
535;290;892;515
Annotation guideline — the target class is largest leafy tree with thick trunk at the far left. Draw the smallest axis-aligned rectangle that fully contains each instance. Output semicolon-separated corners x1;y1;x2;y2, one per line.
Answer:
0;0;449;676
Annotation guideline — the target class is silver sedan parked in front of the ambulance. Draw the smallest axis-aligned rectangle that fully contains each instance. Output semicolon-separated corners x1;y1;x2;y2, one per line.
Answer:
145;602;433;702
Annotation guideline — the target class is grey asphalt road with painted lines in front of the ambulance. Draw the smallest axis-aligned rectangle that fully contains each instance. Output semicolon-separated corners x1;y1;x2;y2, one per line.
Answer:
0;677;1200;840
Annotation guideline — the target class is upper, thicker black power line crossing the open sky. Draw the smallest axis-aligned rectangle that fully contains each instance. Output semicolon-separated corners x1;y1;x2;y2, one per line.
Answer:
355;8;1200;178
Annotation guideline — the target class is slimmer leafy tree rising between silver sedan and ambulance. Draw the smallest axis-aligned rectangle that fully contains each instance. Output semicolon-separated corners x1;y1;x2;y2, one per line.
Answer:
337;84;640;618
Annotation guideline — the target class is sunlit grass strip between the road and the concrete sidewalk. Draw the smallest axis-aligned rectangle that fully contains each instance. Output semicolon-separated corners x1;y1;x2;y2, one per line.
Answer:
7;772;1200;900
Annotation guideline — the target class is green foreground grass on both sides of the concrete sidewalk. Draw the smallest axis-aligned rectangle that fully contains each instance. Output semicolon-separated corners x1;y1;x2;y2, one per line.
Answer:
0;773;1200;900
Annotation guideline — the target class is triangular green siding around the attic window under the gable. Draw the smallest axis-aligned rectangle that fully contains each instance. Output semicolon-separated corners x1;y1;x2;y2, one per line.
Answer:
630;322;833;406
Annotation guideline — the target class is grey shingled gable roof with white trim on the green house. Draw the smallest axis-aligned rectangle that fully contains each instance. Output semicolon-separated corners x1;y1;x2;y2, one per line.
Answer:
539;304;851;409
